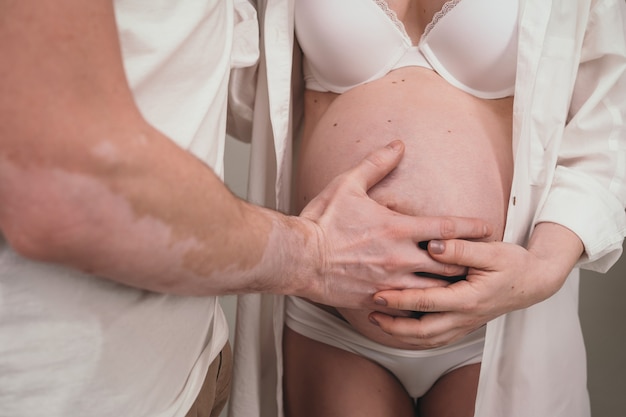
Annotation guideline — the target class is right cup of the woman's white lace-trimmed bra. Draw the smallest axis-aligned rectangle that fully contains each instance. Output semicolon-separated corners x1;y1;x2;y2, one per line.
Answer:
419;0;518;98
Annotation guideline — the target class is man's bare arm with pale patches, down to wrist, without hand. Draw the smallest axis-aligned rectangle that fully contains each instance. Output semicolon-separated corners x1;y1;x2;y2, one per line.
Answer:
0;0;312;294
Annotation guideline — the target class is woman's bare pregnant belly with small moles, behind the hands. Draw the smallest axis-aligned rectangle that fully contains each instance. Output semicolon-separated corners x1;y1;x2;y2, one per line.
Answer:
295;67;513;348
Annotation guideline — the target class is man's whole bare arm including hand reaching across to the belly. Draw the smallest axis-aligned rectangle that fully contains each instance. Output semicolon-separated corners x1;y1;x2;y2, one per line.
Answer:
0;0;489;306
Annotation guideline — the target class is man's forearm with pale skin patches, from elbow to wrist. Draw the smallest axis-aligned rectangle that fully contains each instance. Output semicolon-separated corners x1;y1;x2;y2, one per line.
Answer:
0;119;314;295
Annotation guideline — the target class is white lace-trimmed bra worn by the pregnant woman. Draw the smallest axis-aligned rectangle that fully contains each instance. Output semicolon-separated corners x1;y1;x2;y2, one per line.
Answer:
295;0;518;98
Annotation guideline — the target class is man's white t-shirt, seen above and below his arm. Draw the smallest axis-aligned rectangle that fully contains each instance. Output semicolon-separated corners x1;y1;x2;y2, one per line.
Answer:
0;0;233;417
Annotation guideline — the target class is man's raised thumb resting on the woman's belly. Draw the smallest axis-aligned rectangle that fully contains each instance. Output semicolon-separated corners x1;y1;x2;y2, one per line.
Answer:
352;140;404;191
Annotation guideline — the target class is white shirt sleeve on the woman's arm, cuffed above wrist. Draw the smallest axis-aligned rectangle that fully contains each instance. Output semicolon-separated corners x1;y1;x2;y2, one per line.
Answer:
536;0;626;272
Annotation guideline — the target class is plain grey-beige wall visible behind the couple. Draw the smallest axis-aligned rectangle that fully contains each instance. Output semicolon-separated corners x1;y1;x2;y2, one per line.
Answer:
222;139;626;417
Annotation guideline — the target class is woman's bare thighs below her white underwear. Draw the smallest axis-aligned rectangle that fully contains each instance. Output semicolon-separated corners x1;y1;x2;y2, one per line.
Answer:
283;328;480;417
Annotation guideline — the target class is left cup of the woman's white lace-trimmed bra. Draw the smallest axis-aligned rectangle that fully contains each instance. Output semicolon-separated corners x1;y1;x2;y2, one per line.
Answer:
295;0;411;93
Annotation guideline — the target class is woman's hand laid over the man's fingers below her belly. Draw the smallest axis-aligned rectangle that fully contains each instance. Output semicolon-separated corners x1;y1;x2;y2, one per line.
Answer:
370;223;583;349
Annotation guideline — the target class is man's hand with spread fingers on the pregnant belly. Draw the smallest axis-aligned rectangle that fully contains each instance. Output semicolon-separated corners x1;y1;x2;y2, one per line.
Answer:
298;141;492;308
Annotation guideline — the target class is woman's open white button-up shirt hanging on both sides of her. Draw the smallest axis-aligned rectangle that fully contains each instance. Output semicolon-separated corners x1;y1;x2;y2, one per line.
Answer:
230;0;626;417
